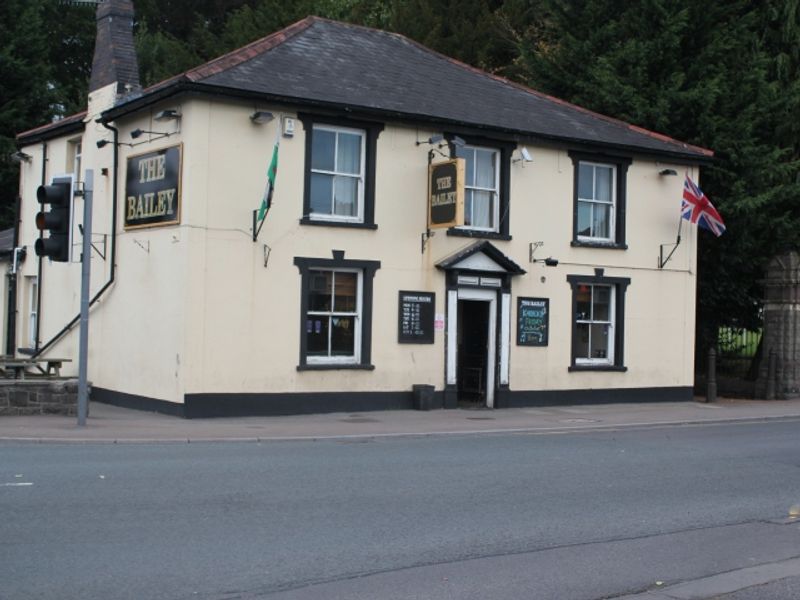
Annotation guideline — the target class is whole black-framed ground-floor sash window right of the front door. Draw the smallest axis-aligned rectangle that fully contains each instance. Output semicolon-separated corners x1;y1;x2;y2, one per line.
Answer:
567;270;630;370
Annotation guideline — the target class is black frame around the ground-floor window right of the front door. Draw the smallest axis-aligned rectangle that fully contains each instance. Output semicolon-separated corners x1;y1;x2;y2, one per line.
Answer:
567;269;631;372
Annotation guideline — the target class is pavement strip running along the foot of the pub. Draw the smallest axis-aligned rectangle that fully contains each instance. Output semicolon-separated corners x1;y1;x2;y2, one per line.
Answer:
0;398;800;443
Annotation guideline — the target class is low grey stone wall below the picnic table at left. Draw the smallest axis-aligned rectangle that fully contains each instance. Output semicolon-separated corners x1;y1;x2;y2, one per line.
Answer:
0;379;84;417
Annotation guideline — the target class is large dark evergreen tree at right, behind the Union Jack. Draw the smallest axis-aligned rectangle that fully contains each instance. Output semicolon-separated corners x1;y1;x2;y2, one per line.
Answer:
518;0;800;348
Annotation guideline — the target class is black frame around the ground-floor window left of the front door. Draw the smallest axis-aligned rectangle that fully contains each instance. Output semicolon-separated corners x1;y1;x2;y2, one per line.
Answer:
294;250;381;371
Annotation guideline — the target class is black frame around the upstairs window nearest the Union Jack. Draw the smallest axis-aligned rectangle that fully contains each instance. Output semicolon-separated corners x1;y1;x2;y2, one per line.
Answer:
569;150;633;250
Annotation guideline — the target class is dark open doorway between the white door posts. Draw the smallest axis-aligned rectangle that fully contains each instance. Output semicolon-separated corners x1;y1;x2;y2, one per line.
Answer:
456;300;493;407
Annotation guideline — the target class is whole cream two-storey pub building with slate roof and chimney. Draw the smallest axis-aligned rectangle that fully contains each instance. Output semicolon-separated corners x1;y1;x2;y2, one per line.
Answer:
12;0;712;417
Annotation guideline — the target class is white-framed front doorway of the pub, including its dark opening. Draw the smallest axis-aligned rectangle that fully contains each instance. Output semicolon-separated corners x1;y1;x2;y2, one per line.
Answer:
447;288;497;408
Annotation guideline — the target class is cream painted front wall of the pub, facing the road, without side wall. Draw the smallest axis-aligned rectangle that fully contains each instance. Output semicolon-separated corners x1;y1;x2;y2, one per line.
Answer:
184;102;696;393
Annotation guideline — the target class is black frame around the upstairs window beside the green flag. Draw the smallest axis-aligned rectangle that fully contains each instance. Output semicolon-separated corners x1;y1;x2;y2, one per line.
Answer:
297;113;384;229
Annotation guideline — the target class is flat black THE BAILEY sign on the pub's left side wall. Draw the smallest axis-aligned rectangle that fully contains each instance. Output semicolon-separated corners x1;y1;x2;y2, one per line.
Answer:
124;144;182;229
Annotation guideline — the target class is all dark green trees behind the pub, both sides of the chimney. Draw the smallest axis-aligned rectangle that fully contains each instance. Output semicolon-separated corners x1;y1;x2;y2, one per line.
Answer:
0;0;800;360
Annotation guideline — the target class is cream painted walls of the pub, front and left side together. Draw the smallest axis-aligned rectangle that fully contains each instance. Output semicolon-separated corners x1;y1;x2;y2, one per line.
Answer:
18;92;697;402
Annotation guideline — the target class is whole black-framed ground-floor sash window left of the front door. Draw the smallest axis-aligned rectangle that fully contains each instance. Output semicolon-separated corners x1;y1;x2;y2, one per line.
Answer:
294;250;380;370
